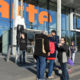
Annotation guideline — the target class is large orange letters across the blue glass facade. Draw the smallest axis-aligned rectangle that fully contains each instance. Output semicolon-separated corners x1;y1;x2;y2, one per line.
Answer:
0;0;52;24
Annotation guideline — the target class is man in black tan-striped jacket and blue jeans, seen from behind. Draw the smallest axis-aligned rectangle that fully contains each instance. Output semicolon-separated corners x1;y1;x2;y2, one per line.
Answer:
34;34;50;80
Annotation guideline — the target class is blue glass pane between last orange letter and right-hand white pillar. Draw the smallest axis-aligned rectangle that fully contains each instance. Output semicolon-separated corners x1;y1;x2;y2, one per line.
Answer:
49;1;57;33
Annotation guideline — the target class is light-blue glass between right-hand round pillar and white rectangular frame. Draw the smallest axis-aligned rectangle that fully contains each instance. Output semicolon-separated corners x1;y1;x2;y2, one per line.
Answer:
61;6;71;45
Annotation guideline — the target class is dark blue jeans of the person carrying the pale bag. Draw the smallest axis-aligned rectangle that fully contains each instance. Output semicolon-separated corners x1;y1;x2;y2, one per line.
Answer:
61;63;69;80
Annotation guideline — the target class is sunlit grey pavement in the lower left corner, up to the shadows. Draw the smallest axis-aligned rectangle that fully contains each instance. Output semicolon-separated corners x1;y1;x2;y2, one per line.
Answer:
0;57;36;80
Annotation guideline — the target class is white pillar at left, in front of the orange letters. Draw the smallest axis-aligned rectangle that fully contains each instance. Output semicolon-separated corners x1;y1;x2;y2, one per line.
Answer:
12;0;18;55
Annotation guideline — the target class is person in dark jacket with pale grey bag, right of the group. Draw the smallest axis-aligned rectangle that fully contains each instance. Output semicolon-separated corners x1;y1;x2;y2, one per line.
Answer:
57;37;69;80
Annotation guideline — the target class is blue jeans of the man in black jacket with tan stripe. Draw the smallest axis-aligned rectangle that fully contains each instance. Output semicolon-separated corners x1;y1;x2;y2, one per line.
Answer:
37;56;46;79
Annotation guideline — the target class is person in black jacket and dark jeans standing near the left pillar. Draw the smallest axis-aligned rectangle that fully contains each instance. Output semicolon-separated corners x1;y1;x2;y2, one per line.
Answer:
19;33;27;64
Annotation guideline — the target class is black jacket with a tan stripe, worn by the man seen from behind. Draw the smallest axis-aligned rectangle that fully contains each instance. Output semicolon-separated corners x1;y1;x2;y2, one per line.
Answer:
34;34;50;58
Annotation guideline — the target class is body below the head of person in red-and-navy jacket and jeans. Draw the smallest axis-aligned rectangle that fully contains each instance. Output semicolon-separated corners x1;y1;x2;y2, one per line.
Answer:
47;37;56;79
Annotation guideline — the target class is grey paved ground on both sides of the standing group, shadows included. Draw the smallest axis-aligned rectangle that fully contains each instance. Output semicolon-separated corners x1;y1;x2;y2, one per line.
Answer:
0;53;80;80
